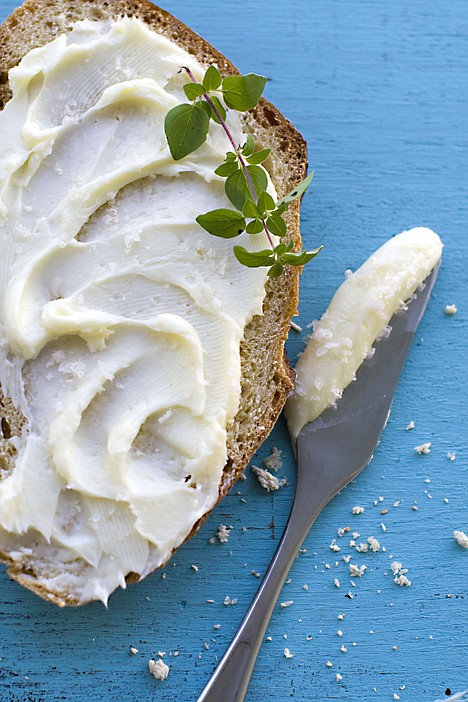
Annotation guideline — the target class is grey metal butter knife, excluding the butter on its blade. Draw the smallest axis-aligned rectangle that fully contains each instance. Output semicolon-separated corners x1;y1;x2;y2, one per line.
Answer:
198;264;439;702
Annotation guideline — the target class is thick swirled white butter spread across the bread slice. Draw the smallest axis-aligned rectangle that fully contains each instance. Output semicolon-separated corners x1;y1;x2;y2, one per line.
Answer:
0;18;274;601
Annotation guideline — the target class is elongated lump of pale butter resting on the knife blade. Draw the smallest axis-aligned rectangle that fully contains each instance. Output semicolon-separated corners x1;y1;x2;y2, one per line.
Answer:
286;227;442;438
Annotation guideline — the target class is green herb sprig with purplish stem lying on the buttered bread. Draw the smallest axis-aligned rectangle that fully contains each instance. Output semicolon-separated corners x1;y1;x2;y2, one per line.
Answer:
164;66;322;278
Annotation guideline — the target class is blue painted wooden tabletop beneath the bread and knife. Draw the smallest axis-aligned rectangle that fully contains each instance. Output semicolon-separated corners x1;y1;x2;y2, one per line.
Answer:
0;0;468;702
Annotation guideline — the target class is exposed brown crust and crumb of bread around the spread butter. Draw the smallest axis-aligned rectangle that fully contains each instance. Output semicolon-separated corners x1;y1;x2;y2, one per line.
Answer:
0;0;307;606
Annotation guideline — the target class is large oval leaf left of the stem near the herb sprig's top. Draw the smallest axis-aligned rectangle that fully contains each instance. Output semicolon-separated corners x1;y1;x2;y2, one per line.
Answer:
164;104;210;161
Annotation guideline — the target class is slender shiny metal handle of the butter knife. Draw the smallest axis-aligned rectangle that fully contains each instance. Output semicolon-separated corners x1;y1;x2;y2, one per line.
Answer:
198;471;332;702
